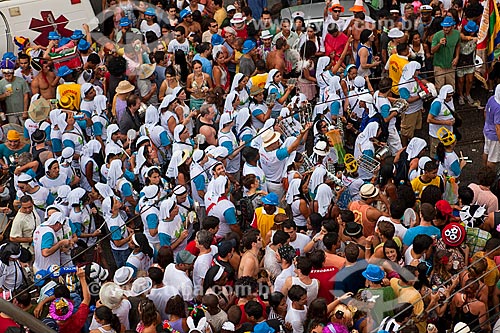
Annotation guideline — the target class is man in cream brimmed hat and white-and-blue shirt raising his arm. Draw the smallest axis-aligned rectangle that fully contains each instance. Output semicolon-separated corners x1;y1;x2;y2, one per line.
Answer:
260;123;311;202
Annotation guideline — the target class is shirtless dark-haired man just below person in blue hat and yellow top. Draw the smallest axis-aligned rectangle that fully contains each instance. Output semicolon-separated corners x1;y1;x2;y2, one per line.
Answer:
238;229;262;279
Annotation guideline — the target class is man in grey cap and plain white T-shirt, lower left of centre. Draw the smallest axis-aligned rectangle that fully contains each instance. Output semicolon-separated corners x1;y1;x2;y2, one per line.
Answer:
163;250;196;302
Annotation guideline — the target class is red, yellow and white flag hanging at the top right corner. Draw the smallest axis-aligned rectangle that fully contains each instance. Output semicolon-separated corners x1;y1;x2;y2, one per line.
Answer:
477;0;500;63
